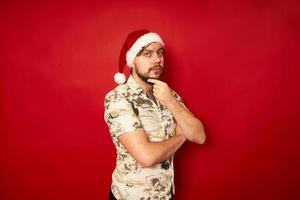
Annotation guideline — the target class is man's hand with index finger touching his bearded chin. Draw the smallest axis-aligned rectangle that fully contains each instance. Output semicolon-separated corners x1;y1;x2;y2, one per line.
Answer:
147;79;175;106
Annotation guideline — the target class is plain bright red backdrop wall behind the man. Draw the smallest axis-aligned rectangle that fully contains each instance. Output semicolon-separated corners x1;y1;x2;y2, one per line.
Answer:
0;0;300;200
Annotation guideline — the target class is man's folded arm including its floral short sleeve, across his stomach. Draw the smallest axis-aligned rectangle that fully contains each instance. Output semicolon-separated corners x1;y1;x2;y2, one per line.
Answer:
104;91;186;167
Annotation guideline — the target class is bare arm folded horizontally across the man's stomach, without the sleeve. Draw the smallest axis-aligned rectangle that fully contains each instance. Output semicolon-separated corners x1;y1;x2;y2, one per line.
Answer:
118;126;186;167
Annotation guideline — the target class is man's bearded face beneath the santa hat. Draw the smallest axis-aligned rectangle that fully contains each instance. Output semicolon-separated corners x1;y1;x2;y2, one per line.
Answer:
132;42;164;82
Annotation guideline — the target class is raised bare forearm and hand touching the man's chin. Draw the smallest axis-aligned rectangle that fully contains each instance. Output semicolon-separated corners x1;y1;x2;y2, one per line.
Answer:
148;79;206;144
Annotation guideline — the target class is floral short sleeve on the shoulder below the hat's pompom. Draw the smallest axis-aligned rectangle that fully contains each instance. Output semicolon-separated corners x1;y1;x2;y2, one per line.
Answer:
104;91;143;138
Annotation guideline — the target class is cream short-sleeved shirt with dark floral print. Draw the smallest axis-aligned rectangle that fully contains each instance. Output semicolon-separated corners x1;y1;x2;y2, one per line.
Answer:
104;76;185;200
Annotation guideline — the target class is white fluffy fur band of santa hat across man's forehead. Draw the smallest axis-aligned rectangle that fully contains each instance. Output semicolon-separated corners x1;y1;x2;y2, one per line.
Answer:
126;32;165;67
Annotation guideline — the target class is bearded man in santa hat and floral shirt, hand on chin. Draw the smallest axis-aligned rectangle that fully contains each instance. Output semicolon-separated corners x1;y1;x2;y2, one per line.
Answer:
104;30;205;200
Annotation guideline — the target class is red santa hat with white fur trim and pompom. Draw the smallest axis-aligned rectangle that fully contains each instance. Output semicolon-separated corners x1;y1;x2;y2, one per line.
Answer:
114;30;164;84
